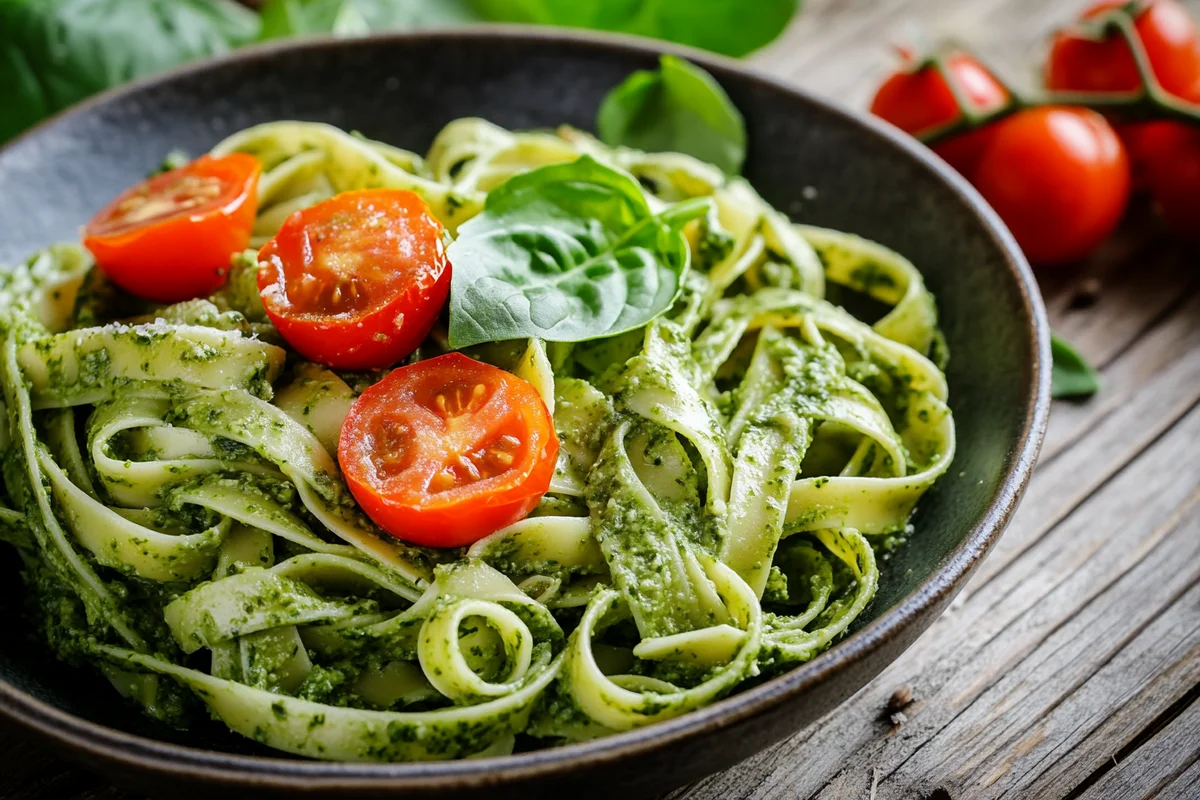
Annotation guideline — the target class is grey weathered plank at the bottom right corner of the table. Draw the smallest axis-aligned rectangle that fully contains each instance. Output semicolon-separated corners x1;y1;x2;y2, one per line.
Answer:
1079;698;1200;800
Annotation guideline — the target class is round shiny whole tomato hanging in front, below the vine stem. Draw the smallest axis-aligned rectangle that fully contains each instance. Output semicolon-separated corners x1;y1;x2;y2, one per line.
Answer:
971;106;1129;265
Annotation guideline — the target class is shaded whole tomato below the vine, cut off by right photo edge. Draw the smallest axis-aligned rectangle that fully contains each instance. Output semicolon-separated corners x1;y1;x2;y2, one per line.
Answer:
1129;121;1200;239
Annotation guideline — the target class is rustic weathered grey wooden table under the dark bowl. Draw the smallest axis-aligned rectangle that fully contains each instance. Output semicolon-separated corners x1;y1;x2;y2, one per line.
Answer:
0;0;1200;800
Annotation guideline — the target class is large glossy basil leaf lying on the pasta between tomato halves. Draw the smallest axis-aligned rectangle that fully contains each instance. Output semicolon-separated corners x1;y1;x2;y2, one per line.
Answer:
448;156;712;348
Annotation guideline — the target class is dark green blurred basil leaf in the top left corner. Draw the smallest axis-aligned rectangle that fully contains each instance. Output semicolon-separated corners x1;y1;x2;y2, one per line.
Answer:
0;0;258;142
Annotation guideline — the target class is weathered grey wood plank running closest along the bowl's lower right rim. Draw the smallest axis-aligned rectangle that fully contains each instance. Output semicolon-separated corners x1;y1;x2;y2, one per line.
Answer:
679;392;1200;800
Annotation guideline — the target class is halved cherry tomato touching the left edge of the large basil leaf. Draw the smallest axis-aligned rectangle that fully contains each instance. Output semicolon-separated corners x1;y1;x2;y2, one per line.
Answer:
258;190;450;369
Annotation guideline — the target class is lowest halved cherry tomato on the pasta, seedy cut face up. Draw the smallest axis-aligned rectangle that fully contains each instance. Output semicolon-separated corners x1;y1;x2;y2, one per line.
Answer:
337;353;558;547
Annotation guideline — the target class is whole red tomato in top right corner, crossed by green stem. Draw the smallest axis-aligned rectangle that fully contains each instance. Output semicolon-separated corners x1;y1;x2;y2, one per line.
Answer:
1046;0;1200;97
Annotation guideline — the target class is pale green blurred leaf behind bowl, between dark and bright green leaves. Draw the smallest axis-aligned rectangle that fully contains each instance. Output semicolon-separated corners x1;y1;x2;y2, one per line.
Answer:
262;0;480;40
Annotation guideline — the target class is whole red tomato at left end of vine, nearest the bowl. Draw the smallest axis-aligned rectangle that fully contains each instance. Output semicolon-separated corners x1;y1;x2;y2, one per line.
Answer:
871;53;1009;175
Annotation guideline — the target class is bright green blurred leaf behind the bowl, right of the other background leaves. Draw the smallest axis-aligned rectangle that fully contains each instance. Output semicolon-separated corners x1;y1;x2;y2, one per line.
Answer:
473;0;799;56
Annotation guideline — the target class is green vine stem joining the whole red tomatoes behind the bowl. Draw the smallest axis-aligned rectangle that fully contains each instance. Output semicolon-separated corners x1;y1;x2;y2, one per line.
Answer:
913;2;1200;145
